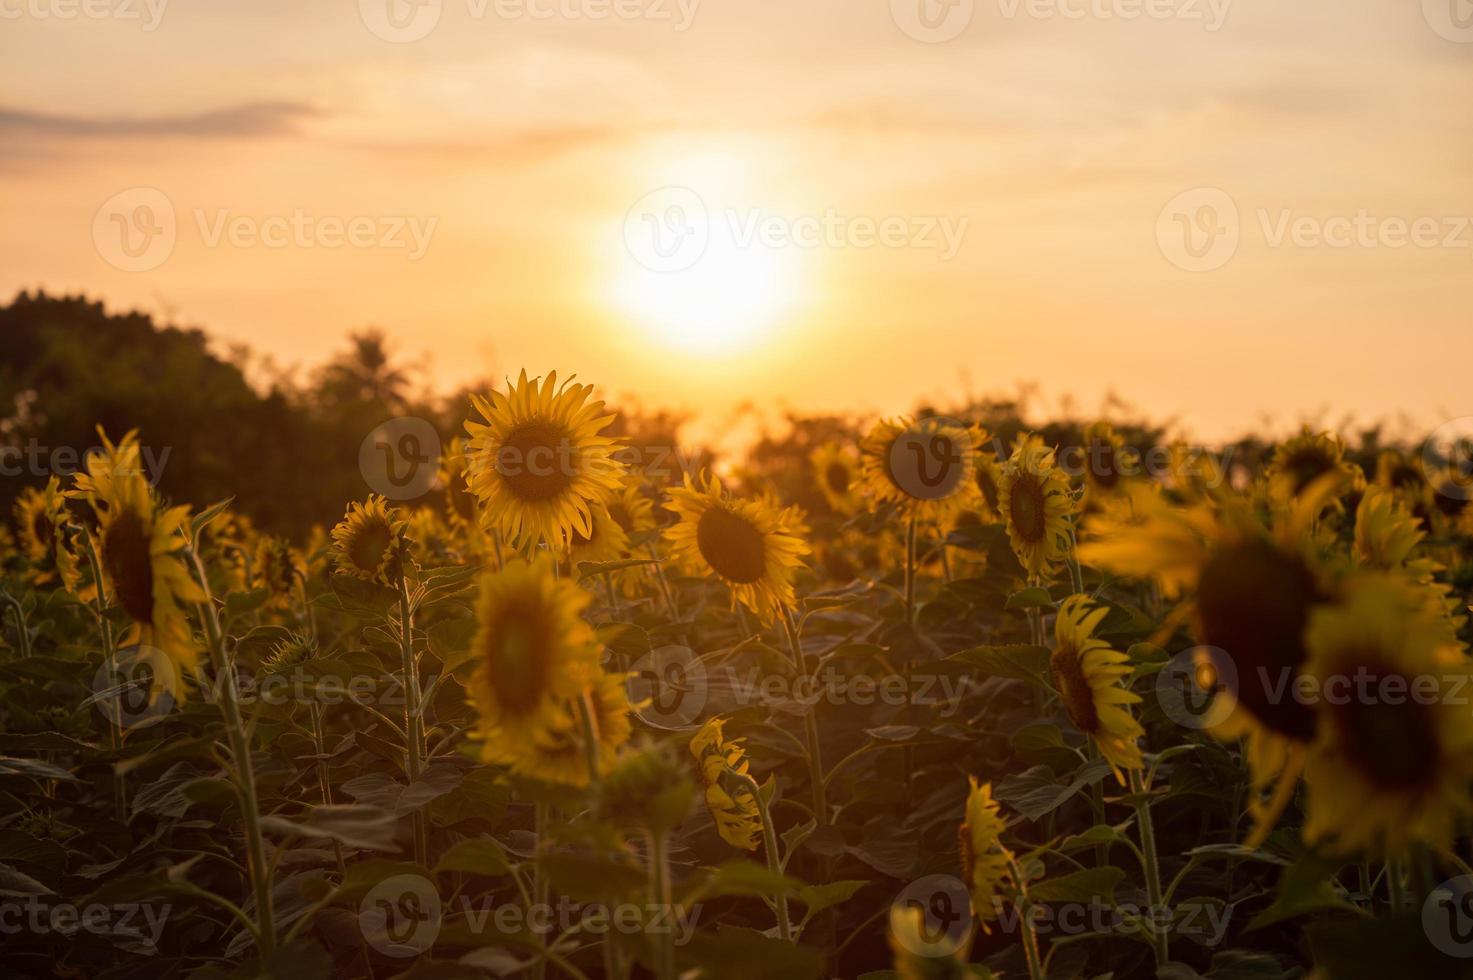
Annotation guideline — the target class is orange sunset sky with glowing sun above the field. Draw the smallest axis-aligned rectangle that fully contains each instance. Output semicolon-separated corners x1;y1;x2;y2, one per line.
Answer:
0;0;1473;438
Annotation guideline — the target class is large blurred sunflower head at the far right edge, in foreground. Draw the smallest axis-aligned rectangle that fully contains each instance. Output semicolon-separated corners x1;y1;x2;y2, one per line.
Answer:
1304;578;1473;856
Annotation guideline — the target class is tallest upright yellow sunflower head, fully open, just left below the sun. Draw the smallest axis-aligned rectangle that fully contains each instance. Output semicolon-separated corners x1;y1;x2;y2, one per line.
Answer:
465;371;626;550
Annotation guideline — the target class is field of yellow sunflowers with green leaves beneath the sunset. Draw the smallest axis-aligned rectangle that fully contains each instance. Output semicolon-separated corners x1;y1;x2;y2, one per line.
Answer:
0;373;1473;980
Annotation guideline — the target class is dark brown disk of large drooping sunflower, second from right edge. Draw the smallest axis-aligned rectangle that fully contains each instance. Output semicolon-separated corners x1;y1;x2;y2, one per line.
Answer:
1198;541;1320;741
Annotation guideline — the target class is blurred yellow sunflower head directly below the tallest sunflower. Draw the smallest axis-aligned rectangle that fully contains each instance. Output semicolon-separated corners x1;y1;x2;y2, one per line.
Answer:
467;556;600;762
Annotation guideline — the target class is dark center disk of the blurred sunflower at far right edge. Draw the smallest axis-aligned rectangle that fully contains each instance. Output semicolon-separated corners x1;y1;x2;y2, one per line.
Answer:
1332;668;1442;790
